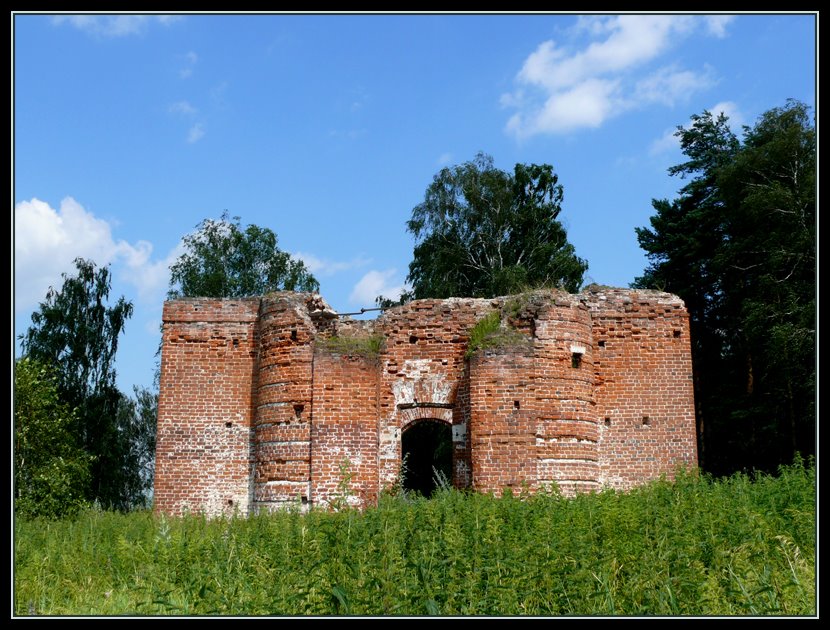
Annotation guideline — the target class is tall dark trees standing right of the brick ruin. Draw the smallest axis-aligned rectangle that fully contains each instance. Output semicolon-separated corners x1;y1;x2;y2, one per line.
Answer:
635;101;816;472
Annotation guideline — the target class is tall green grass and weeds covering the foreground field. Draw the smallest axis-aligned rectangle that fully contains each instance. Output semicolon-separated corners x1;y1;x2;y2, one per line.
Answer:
14;465;816;615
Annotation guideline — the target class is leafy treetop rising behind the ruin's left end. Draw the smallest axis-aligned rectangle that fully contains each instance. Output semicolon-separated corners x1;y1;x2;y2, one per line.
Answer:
168;212;320;299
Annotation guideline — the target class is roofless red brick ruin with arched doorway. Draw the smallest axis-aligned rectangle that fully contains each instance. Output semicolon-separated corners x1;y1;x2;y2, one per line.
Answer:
154;287;697;515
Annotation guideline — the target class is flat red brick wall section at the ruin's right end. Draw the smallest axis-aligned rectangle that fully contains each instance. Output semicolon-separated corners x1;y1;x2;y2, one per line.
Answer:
585;289;697;489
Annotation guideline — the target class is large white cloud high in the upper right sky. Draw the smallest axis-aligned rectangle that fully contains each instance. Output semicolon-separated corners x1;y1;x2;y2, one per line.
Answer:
500;15;725;138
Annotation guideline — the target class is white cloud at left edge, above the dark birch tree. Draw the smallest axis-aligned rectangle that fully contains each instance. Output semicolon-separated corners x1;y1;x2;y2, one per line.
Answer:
14;197;178;311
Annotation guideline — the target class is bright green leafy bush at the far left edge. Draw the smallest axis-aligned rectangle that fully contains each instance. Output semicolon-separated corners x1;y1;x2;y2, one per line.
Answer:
14;357;91;518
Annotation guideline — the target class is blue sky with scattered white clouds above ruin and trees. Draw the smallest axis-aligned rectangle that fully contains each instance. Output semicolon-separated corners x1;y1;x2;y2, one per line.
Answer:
12;14;817;392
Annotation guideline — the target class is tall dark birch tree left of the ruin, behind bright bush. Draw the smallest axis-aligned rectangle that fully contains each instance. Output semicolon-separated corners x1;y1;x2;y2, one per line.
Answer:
21;258;141;509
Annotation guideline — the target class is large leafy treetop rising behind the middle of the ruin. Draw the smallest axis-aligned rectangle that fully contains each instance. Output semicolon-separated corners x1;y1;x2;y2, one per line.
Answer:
404;153;588;302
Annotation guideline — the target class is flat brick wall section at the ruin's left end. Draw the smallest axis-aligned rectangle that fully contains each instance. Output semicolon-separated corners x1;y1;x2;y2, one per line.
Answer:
154;299;259;514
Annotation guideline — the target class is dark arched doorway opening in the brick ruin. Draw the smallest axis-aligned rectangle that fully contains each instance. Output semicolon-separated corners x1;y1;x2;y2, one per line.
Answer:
401;420;452;497
